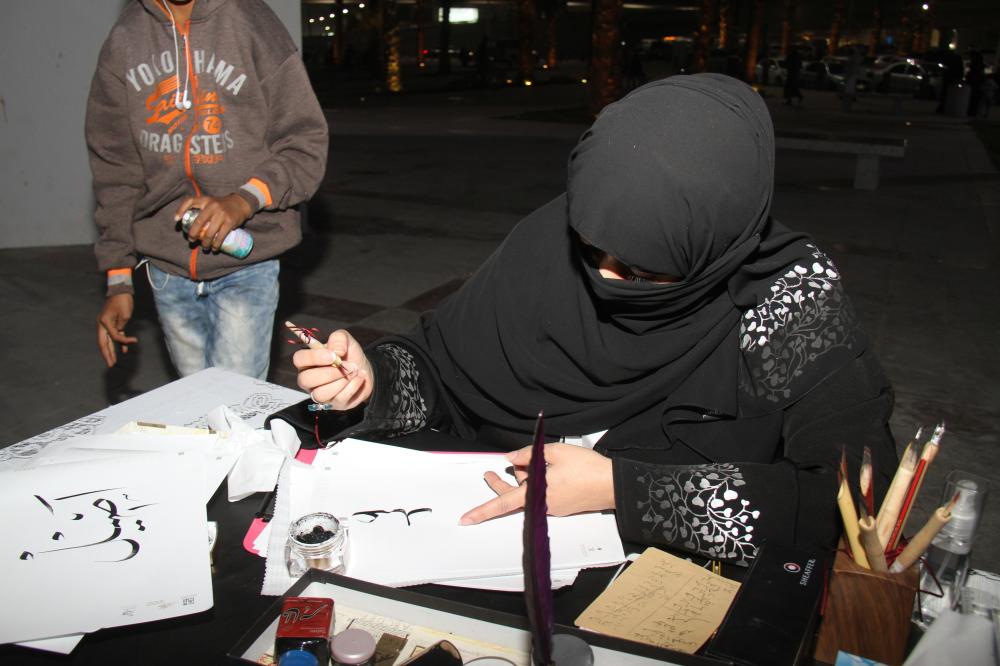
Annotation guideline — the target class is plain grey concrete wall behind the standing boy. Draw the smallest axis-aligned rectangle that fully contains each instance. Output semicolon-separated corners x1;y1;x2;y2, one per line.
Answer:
0;0;301;247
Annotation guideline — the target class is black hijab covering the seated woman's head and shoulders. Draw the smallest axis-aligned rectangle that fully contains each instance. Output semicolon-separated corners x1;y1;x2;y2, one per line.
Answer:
406;74;844;445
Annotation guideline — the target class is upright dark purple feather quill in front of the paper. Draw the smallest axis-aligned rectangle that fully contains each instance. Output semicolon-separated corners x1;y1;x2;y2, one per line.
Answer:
523;412;555;666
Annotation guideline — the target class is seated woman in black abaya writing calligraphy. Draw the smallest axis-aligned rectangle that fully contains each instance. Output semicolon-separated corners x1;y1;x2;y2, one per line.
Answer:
294;74;895;563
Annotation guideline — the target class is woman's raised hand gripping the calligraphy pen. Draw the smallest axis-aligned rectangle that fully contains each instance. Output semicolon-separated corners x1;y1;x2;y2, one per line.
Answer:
292;329;374;410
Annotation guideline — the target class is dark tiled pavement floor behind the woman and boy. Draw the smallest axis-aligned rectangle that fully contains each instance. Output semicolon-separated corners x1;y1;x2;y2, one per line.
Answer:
0;80;1000;571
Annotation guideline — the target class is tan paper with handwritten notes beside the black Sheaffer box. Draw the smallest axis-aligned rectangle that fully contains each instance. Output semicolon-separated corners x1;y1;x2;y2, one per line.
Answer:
576;548;740;654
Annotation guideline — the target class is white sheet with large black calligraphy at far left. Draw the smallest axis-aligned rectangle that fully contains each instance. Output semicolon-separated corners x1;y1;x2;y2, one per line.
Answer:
0;454;212;643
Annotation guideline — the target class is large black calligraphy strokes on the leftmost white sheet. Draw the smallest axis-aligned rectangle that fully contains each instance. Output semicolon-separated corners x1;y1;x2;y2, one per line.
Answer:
19;488;155;562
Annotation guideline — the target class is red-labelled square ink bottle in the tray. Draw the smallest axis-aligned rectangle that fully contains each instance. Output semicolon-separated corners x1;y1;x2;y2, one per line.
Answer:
274;597;333;666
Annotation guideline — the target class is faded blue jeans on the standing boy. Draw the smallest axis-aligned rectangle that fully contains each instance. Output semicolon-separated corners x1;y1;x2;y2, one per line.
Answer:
147;259;279;379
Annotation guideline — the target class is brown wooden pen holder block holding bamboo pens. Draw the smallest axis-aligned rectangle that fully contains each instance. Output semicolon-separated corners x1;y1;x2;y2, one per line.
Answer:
813;550;918;666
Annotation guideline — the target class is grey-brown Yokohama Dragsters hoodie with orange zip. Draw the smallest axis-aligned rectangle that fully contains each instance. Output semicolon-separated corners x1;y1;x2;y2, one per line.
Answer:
86;0;329;295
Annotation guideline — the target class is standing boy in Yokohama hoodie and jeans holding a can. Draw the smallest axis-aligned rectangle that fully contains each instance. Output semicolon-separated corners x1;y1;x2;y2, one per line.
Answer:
86;0;329;379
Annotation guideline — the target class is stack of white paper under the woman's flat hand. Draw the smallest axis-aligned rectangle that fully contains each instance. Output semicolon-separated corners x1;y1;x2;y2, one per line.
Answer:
264;440;625;593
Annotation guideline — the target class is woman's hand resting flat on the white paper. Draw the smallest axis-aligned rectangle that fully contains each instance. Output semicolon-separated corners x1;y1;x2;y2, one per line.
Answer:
460;444;615;525
